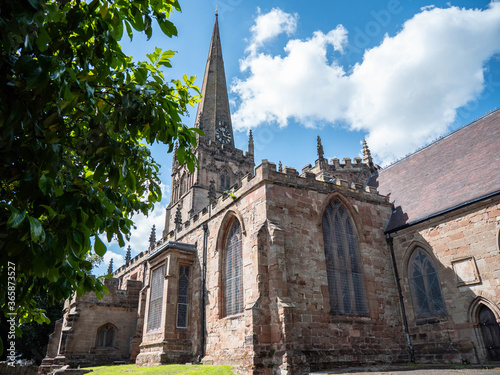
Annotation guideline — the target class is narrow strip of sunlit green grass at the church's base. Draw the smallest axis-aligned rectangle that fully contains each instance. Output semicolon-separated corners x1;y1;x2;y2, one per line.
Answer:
90;365;234;375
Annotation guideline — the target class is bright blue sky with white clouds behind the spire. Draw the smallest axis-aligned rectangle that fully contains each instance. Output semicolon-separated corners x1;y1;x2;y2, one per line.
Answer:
94;0;500;275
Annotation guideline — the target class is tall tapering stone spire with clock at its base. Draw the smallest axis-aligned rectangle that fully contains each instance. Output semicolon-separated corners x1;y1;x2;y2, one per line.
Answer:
195;13;234;147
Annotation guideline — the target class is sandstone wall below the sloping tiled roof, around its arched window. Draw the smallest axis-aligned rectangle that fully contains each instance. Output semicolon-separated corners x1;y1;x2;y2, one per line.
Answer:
393;198;500;363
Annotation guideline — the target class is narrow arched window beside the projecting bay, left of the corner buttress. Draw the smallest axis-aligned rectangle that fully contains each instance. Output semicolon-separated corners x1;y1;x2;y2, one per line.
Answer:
224;219;243;316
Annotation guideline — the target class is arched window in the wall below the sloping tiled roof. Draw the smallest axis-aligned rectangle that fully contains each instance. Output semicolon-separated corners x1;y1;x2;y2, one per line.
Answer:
408;247;446;318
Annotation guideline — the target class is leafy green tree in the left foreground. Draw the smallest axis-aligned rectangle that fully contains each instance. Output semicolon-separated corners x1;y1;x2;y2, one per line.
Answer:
0;0;199;346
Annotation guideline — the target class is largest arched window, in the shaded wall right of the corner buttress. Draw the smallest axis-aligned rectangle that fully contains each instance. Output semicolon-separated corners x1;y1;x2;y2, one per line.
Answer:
323;199;368;316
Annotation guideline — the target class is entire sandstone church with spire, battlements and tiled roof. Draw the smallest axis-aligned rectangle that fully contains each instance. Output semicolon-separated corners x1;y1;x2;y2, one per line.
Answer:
40;14;500;375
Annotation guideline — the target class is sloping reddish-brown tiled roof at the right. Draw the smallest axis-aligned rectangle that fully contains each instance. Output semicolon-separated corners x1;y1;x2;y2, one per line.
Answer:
368;109;500;232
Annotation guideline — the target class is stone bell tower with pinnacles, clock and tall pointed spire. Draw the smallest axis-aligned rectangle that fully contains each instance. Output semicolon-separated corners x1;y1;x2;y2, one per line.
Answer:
163;13;255;236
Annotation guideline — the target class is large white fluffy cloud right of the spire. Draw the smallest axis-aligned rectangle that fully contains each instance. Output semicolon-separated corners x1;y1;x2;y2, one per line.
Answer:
232;2;500;163
